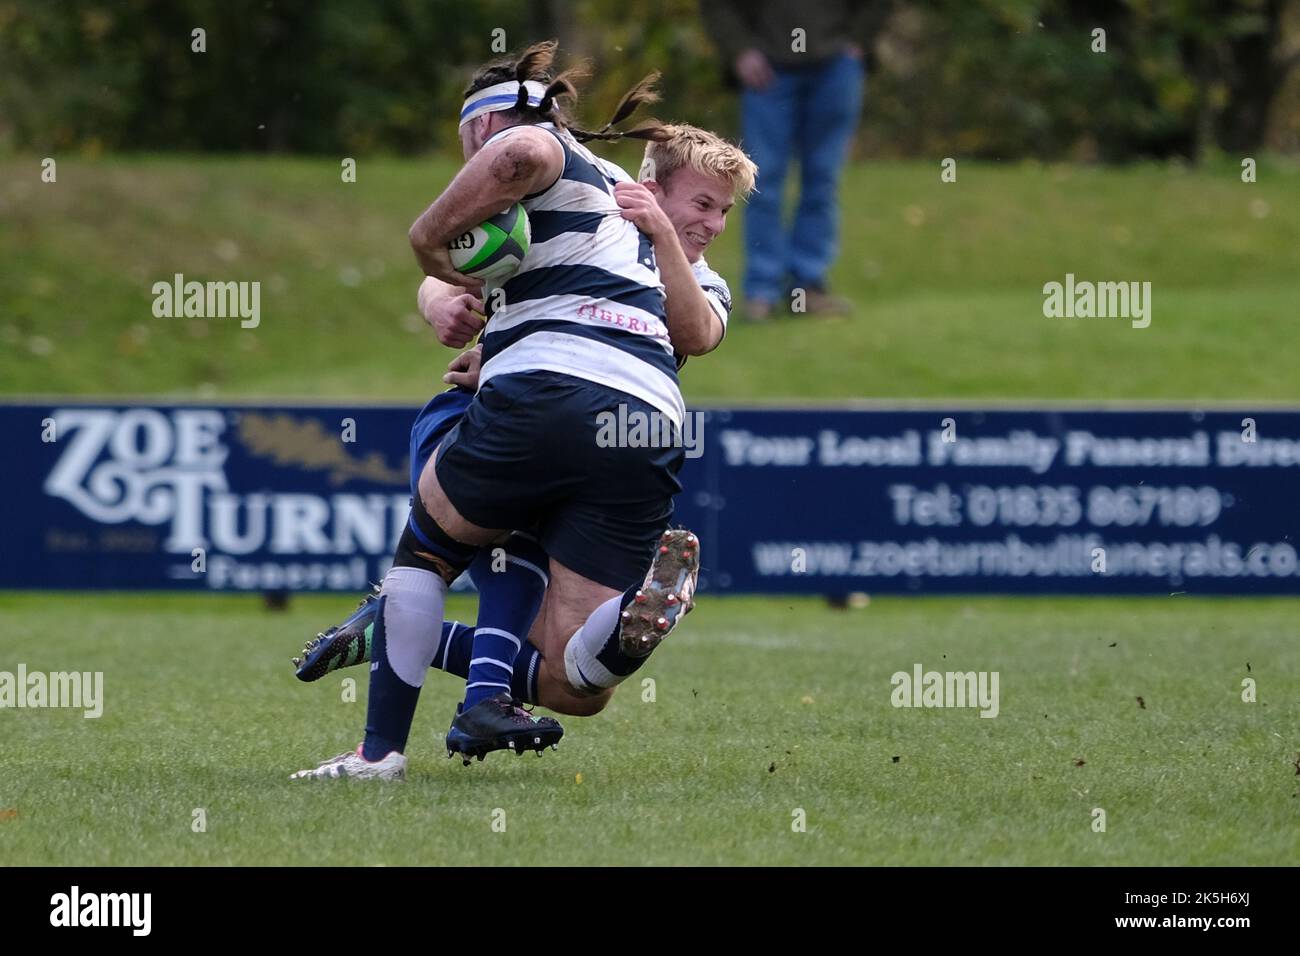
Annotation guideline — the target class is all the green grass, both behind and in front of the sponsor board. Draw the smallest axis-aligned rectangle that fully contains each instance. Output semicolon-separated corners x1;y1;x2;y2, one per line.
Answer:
0;156;1300;865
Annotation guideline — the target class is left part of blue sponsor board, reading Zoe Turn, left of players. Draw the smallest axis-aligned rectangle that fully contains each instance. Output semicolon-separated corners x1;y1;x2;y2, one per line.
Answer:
0;402;415;591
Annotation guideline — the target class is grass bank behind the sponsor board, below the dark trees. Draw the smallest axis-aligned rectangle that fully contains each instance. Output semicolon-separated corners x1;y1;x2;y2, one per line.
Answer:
0;153;1300;403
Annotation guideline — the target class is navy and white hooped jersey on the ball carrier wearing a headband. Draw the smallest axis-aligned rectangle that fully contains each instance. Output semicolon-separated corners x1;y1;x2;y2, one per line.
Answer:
478;124;685;428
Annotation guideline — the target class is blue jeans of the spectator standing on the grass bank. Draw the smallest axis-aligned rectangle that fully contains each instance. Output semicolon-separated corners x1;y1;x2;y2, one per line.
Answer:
741;55;865;302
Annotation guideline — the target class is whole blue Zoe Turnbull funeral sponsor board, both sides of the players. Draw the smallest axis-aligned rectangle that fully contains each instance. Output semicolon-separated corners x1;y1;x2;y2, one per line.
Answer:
0;402;1300;594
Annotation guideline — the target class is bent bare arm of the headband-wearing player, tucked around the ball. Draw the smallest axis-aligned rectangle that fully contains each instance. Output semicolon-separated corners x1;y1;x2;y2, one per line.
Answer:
408;126;564;291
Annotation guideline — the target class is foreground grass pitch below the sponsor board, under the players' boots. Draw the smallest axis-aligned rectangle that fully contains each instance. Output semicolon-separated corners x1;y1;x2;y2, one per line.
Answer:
0;594;1300;865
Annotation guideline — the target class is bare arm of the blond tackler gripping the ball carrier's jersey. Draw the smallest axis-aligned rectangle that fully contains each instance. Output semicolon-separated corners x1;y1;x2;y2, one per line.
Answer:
614;182;724;355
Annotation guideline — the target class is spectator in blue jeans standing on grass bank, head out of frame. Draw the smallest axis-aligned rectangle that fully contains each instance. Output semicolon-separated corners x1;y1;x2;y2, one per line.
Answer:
701;0;879;321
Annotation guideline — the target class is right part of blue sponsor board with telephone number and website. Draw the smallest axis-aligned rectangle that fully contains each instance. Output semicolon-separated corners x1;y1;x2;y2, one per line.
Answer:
688;410;1300;594
